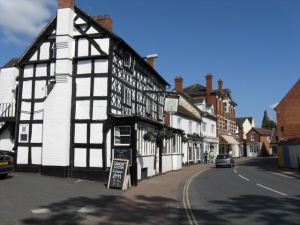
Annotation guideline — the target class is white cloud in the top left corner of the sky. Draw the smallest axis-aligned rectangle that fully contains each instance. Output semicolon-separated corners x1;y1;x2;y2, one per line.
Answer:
0;0;57;43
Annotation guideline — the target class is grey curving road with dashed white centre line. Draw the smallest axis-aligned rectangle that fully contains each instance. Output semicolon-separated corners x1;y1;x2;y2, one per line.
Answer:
179;158;300;225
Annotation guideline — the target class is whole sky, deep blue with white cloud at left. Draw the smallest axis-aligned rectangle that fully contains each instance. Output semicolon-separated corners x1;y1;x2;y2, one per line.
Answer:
0;0;300;127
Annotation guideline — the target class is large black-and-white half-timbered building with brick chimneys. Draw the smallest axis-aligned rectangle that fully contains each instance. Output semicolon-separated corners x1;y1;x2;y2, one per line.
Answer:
0;0;181;185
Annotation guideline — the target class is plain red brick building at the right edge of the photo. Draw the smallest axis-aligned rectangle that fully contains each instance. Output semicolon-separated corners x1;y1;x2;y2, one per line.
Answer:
274;79;300;142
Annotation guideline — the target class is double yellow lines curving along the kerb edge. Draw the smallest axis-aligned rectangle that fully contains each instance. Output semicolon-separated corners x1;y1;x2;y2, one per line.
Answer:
182;169;209;225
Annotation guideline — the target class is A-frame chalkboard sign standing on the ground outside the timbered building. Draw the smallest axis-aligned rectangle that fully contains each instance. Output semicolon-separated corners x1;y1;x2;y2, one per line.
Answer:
107;159;128;190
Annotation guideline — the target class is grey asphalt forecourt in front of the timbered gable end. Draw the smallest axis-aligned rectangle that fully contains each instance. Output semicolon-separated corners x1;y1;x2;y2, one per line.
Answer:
0;172;123;225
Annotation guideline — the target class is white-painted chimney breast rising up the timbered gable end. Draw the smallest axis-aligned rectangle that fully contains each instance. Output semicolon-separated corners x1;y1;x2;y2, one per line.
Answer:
42;8;74;166
